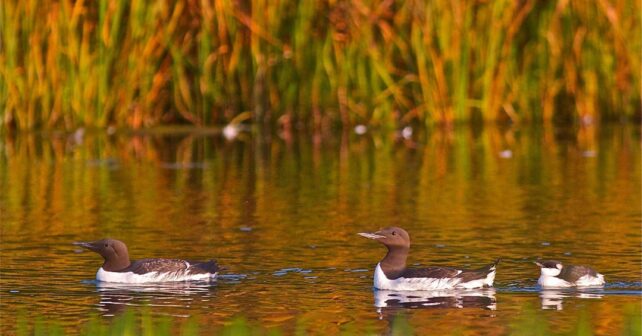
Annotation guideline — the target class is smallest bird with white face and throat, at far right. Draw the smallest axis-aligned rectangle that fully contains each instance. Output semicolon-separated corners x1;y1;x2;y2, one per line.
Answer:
535;260;605;287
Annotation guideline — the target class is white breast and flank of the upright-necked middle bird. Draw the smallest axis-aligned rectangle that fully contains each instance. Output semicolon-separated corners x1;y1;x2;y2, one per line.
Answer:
374;264;495;291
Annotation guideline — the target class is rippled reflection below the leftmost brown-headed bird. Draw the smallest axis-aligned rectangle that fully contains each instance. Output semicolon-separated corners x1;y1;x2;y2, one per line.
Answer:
96;281;215;316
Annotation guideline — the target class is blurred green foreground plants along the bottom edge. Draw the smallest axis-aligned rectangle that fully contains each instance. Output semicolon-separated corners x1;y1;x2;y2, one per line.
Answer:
8;305;642;336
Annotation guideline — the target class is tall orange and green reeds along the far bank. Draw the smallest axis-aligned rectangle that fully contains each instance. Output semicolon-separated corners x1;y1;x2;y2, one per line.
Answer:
0;0;642;129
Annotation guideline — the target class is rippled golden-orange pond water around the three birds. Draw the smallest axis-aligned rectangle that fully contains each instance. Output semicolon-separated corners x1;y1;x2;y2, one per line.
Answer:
0;126;642;334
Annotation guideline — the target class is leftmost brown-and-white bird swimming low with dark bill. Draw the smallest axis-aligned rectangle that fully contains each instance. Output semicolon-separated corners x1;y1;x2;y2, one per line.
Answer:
74;238;219;283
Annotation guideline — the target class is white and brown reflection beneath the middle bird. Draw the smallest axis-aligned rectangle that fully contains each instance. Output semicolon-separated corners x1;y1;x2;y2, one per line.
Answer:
374;288;497;319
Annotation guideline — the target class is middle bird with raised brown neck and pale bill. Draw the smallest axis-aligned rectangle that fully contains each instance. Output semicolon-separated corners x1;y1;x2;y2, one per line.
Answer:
359;227;499;290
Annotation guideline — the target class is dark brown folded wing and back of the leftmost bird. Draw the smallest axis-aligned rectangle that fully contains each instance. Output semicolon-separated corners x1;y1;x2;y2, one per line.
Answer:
121;259;218;274
